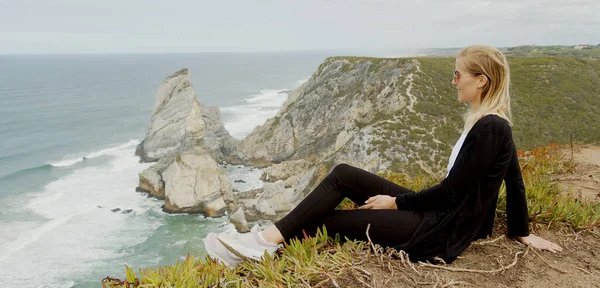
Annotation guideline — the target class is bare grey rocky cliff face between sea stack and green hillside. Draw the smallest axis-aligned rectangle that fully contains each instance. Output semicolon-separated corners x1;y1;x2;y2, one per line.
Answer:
227;57;434;205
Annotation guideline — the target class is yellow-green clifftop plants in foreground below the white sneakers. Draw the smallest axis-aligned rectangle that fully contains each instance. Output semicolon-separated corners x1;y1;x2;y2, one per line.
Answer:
102;229;368;287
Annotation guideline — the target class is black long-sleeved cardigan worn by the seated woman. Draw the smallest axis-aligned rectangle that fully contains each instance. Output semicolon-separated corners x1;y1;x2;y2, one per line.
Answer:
394;115;529;262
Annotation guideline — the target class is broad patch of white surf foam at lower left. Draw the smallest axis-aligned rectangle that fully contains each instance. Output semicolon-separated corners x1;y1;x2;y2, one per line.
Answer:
0;141;163;287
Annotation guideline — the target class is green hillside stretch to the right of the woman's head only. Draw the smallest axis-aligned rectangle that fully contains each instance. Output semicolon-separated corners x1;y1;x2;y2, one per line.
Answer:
509;57;600;149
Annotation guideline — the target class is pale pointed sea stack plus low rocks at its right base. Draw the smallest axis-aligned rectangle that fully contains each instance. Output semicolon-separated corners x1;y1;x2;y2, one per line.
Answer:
135;69;318;232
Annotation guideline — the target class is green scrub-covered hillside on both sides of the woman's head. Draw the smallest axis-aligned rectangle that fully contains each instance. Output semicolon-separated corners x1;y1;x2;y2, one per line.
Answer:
336;57;600;176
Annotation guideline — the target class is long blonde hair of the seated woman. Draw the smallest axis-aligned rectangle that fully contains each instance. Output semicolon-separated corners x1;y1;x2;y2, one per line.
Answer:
456;45;512;130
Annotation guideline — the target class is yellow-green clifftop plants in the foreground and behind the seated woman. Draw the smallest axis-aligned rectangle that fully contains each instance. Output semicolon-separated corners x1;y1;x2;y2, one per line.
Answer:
102;144;600;287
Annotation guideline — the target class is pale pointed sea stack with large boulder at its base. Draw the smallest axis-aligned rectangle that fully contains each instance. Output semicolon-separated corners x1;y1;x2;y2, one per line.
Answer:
136;69;239;217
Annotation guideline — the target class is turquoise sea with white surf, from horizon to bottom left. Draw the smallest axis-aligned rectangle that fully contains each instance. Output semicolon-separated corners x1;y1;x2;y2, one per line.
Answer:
0;53;328;287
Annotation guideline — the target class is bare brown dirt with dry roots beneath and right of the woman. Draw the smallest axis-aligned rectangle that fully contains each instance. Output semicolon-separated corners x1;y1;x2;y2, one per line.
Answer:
330;145;600;288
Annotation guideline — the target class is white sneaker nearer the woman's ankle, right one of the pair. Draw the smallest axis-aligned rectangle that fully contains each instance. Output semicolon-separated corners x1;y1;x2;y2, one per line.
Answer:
217;225;282;261
